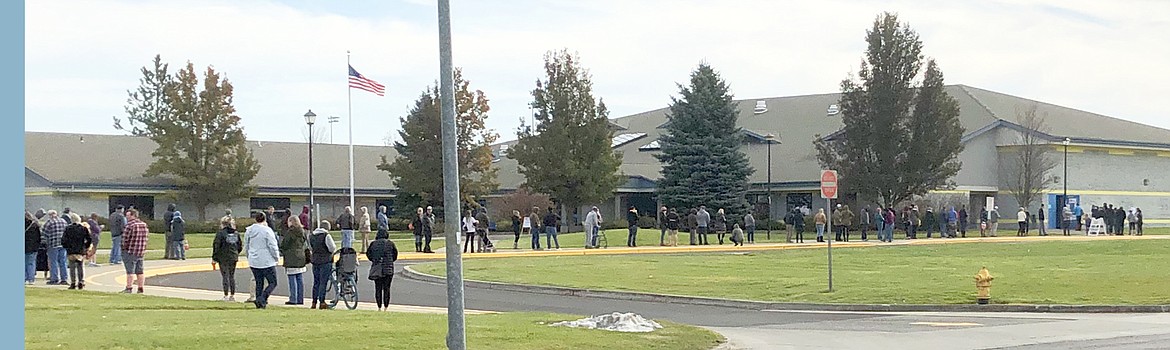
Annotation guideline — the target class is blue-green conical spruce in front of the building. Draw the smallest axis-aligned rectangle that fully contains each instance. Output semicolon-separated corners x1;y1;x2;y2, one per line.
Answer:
655;63;753;217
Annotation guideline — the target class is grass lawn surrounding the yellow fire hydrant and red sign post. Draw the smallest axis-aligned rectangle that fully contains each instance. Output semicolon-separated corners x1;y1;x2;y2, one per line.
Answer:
417;240;1170;304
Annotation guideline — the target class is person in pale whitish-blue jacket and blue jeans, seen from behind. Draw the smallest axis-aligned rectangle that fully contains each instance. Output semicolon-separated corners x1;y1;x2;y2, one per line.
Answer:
245;213;281;309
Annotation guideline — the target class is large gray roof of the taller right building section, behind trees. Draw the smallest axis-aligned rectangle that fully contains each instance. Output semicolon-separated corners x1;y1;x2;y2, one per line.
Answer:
495;85;1170;188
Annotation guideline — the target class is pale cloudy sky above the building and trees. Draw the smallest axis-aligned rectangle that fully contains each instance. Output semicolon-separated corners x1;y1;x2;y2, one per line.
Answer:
25;0;1170;145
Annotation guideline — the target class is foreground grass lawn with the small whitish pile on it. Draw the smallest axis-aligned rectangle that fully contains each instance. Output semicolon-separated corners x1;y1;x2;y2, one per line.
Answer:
25;288;722;350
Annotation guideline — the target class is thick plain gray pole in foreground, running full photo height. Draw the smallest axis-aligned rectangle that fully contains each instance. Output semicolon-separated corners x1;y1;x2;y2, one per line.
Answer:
439;0;467;350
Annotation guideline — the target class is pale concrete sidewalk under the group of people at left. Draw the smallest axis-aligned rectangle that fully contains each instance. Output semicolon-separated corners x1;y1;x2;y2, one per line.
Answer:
26;259;493;315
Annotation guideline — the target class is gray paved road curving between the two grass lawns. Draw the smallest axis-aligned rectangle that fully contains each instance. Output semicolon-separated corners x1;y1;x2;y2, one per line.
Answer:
147;261;1170;350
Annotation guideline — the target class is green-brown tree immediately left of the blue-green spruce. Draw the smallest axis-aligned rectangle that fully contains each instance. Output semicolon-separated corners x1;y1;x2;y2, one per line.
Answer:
508;50;625;224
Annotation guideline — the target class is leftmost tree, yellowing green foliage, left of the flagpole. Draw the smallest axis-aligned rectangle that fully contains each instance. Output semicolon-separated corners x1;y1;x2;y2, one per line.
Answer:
115;56;260;220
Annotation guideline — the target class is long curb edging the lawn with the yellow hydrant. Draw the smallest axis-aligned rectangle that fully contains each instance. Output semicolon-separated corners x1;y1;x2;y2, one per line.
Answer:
402;266;1170;314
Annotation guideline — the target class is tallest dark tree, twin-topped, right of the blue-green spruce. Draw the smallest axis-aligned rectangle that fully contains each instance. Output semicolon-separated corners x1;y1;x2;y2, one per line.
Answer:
817;13;964;206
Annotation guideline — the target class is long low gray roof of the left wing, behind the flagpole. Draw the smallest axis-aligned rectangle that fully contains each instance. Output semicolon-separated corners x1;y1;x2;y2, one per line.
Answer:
25;131;397;192
